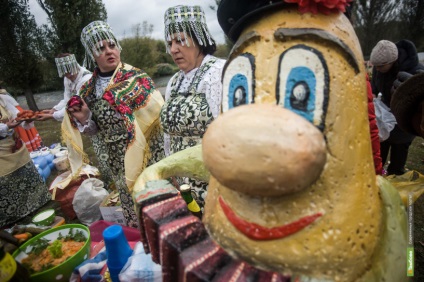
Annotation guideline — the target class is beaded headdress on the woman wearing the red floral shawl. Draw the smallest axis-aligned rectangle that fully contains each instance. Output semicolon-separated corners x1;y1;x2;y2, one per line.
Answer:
81;21;122;66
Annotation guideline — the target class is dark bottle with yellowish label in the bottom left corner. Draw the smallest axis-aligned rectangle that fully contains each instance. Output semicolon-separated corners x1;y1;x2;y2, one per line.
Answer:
0;246;29;282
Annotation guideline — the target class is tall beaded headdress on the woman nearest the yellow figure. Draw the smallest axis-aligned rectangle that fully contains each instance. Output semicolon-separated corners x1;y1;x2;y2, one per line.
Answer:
164;5;215;53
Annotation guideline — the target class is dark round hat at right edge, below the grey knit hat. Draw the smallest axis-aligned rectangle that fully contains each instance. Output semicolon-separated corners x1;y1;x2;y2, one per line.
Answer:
390;72;424;135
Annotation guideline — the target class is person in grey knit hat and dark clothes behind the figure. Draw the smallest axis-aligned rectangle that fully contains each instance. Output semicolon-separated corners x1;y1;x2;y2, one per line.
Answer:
370;39;424;175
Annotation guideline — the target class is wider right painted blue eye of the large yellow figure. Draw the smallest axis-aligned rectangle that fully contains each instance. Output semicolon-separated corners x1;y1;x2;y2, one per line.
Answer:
276;45;329;130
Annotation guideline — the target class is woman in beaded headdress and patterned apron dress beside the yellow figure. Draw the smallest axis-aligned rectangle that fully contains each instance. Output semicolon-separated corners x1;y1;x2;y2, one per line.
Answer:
161;6;225;207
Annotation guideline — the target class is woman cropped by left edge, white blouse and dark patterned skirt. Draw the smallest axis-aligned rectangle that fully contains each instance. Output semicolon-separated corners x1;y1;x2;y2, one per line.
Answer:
0;94;51;227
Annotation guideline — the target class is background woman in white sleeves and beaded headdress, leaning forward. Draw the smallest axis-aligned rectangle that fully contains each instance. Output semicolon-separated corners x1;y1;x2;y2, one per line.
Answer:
37;53;91;121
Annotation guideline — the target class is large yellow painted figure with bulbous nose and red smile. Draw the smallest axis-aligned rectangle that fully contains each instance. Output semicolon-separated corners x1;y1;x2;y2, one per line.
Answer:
133;0;406;281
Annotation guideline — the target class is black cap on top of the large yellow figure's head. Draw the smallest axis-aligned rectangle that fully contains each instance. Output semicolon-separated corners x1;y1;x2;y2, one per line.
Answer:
218;0;290;42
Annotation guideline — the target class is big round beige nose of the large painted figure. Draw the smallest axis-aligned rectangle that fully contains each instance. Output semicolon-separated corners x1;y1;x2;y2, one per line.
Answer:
202;104;326;196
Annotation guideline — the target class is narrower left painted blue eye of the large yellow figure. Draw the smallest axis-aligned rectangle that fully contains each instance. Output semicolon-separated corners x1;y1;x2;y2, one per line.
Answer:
222;53;255;112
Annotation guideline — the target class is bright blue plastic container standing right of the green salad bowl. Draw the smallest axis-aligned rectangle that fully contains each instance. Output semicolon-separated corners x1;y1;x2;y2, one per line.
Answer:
103;225;132;282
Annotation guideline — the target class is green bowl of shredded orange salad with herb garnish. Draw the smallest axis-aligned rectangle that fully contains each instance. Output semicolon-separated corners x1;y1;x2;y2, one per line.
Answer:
13;224;91;282
